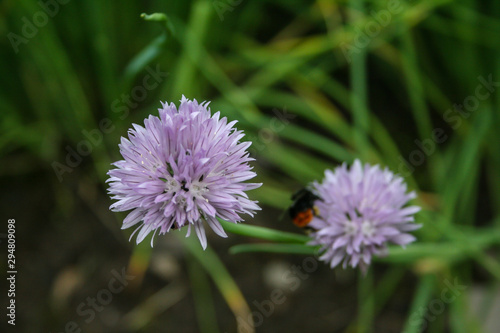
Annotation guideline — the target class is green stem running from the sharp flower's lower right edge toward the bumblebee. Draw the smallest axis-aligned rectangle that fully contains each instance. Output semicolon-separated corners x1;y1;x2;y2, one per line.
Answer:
219;219;311;244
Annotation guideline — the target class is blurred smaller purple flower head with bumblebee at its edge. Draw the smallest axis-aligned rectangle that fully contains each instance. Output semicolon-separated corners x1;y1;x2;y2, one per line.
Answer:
310;160;420;273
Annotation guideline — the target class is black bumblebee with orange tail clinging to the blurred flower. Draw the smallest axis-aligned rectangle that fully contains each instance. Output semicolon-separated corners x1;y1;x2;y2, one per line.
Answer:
288;188;321;228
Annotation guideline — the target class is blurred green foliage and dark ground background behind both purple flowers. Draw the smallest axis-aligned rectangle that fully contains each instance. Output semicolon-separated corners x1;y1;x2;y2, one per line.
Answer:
0;0;500;332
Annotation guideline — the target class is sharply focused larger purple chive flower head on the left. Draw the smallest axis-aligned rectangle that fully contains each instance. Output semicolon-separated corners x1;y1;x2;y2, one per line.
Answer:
107;96;261;248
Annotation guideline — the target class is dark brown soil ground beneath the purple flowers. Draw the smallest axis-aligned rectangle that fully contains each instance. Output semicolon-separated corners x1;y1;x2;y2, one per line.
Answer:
0;172;414;333
